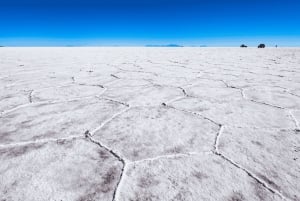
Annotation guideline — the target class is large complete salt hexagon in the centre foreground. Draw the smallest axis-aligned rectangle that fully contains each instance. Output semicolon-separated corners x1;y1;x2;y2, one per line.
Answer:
93;107;219;161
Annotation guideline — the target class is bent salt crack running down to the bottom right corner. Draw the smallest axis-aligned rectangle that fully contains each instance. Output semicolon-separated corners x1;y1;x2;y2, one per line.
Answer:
213;125;287;200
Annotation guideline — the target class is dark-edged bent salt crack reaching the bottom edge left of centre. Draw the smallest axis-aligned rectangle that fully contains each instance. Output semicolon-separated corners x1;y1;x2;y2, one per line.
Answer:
84;130;126;201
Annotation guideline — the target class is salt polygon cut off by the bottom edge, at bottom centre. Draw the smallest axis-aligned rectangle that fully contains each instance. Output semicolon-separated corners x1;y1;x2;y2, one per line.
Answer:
117;154;281;201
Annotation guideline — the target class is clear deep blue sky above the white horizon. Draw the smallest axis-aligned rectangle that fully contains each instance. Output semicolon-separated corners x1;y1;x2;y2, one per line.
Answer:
0;0;300;46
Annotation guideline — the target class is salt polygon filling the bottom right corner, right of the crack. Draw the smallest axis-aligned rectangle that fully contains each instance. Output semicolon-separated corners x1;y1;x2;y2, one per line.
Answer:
219;128;300;200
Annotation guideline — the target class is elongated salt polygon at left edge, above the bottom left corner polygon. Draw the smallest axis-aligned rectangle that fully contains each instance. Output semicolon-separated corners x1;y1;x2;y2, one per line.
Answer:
0;98;125;145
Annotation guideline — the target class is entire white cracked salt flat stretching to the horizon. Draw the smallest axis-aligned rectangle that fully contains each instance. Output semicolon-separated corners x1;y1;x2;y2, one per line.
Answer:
0;48;300;201
